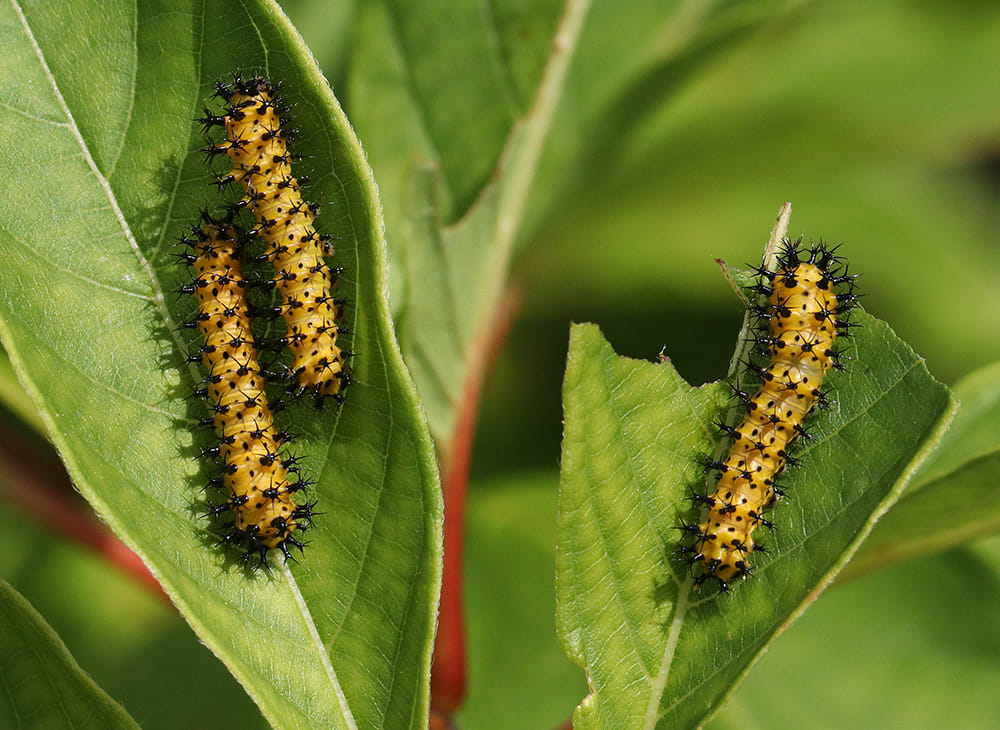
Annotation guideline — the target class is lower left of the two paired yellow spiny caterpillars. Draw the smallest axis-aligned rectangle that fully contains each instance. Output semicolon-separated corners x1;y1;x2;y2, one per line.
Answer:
181;216;312;566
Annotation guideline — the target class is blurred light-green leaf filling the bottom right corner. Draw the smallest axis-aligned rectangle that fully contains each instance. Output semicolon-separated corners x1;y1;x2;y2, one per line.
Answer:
708;537;1000;730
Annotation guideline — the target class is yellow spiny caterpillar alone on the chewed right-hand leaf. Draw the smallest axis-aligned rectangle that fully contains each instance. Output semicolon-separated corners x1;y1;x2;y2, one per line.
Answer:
681;239;856;591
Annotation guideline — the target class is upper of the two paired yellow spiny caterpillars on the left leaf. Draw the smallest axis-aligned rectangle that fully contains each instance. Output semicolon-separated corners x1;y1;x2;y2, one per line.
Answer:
199;76;350;404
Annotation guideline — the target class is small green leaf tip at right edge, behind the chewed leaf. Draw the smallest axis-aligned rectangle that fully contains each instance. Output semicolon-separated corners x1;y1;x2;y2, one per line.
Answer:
842;363;1000;578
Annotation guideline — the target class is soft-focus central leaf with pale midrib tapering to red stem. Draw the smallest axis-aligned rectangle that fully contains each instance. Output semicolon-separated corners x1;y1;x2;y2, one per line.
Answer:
349;0;785;443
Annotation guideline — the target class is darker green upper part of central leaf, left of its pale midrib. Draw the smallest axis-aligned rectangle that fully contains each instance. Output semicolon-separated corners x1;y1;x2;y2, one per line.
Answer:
349;0;564;225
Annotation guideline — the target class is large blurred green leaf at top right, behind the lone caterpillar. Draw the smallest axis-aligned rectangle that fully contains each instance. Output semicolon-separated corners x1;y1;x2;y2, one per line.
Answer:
522;0;1000;382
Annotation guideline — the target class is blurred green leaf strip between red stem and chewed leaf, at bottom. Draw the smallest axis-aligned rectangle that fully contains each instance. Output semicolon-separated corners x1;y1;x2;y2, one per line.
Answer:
456;470;586;730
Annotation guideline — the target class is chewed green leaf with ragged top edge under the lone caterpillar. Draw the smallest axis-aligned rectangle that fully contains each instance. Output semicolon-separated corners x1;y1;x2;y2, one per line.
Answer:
557;313;952;728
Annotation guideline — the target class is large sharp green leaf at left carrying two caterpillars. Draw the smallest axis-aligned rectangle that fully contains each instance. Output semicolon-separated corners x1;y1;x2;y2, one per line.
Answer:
0;1;441;727
